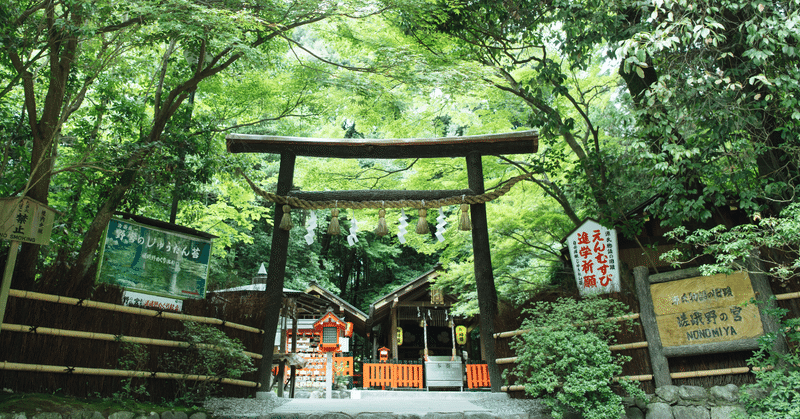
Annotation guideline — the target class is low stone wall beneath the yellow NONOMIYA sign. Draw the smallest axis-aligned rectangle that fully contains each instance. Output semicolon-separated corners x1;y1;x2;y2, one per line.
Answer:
626;384;747;419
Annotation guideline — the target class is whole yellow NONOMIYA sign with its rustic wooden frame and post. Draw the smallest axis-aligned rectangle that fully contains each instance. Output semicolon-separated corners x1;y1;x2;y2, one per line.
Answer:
634;266;780;387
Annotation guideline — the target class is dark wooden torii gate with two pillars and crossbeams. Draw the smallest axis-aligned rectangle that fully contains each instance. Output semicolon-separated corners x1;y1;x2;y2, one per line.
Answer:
226;131;538;392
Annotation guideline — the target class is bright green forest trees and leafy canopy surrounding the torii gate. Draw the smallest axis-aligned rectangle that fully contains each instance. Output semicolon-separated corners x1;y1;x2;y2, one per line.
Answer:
0;0;800;314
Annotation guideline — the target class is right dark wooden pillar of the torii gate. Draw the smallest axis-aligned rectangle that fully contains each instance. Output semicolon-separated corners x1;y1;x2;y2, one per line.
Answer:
467;153;502;393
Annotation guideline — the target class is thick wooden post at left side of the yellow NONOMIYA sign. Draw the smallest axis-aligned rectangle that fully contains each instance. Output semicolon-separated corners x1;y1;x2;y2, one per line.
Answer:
633;266;672;387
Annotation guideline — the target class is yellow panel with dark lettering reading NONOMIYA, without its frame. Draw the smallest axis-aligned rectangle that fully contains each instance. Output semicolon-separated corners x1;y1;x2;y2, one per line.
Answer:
650;273;763;347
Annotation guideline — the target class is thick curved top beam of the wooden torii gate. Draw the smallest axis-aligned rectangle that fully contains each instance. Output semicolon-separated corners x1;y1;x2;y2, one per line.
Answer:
225;131;539;159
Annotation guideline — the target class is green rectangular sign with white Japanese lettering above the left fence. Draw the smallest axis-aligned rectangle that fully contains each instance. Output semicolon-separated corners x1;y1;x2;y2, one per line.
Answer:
97;218;211;299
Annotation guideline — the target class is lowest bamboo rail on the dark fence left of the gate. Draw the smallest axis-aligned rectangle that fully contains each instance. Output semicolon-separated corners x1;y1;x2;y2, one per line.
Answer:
0;361;259;388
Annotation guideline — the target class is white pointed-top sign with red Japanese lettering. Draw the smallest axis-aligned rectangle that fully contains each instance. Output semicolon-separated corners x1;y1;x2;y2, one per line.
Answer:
567;220;620;295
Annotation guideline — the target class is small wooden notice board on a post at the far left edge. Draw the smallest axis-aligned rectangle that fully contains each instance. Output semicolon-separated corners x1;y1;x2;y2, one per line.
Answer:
0;198;56;245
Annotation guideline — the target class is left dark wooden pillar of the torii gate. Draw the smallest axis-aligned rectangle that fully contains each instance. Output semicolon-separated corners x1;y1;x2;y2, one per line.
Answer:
258;153;296;391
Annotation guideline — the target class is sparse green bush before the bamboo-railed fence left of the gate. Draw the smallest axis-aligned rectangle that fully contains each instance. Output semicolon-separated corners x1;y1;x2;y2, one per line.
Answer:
159;322;255;404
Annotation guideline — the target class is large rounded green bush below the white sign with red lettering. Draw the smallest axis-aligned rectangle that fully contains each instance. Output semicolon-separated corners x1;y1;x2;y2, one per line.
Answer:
504;298;644;419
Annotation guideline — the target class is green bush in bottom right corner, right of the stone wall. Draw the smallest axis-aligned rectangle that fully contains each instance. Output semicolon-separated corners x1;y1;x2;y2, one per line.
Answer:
740;302;800;419
